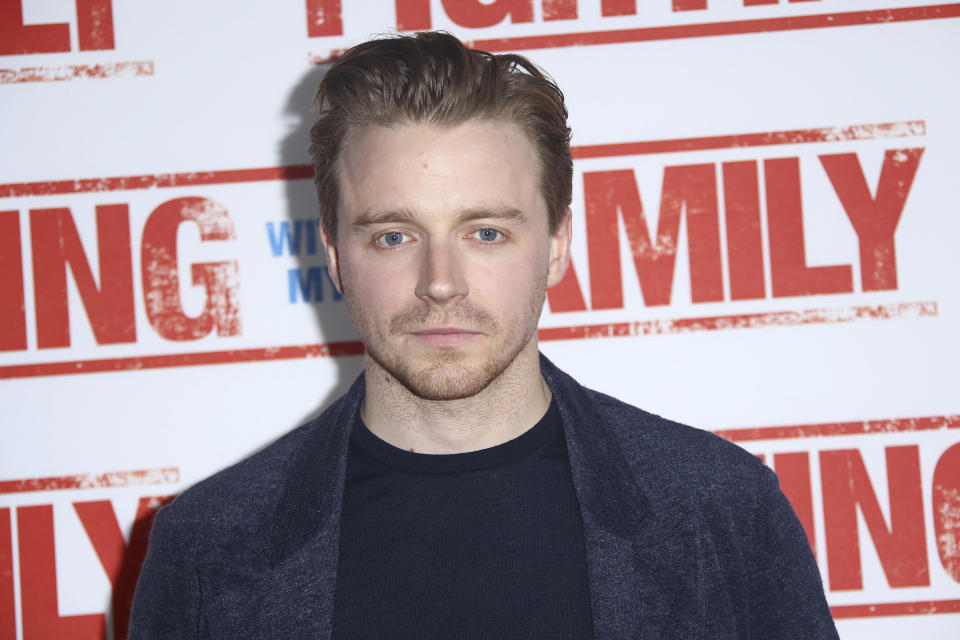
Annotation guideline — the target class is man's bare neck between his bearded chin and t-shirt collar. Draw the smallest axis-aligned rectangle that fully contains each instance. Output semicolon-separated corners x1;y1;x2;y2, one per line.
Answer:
361;338;551;454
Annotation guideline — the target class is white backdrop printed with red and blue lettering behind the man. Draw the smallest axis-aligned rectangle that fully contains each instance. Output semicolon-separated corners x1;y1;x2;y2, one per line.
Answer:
0;0;960;640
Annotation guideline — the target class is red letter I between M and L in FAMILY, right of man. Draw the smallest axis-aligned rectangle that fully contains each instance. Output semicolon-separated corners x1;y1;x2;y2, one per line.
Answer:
723;160;765;300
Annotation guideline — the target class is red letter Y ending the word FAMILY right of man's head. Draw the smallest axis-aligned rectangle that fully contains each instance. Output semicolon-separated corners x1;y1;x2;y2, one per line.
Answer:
820;149;923;291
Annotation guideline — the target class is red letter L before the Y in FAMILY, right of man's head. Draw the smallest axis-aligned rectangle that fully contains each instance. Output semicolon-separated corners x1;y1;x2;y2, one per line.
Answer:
763;158;853;298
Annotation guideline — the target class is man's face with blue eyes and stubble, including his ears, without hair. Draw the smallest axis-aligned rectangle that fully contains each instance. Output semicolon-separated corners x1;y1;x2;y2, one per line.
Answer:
327;121;570;400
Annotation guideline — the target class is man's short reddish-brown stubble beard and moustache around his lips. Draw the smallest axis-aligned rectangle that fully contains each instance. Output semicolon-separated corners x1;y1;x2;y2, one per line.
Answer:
344;274;547;401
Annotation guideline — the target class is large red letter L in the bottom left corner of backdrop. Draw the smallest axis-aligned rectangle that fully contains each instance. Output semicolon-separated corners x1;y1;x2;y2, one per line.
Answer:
17;505;106;640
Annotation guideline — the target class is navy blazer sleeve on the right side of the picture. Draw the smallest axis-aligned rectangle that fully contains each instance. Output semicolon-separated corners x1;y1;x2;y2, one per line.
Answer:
751;467;838;640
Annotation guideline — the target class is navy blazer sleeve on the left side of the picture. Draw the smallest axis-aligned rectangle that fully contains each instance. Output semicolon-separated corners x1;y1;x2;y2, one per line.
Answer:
129;504;205;640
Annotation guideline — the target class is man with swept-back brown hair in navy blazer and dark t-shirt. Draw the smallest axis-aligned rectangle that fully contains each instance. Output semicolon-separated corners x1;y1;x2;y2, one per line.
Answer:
131;33;836;640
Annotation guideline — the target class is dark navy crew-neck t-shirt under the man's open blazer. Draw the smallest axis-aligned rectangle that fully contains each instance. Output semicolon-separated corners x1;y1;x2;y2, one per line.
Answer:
333;403;593;640
